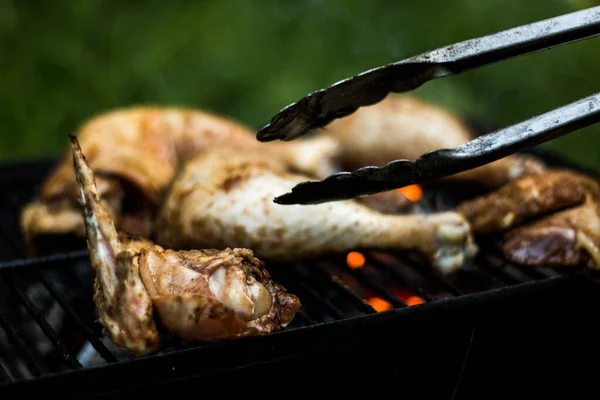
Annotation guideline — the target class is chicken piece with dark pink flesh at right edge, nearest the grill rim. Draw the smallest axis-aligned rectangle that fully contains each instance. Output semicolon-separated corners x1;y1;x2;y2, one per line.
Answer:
503;202;600;269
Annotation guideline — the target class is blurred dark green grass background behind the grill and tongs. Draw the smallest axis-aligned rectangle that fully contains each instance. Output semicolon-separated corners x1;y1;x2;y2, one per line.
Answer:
0;0;600;169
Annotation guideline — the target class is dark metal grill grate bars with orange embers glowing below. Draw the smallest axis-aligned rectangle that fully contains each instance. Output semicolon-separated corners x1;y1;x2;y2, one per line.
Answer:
0;152;592;384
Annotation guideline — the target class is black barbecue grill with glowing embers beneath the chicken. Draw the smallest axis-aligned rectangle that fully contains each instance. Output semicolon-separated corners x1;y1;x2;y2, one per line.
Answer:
0;145;600;399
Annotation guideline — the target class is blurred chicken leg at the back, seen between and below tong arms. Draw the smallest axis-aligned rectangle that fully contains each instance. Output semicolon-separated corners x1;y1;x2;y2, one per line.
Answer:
315;93;543;188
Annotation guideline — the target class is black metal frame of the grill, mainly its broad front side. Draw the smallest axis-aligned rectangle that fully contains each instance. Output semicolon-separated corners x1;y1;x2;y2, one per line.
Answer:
0;151;600;398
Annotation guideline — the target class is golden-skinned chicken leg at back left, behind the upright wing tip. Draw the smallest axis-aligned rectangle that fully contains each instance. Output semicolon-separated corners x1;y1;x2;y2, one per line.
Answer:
21;106;340;253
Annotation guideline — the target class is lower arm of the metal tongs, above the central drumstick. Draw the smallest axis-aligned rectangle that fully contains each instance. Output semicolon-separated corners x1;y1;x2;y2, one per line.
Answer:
274;93;600;204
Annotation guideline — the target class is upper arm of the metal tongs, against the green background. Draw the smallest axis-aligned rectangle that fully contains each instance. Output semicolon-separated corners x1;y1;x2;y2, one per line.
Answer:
256;6;600;142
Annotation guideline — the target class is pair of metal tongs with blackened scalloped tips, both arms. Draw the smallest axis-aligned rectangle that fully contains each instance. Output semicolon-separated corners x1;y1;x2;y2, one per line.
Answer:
256;6;600;204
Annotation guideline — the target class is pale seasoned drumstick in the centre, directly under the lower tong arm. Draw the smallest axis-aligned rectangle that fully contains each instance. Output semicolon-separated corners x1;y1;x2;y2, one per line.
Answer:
156;149;476;272
